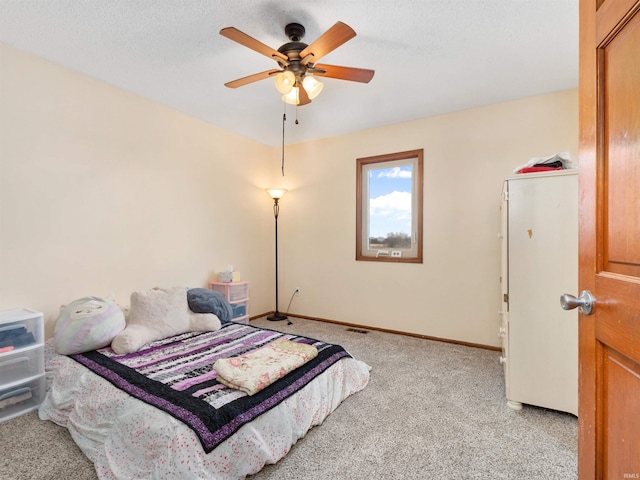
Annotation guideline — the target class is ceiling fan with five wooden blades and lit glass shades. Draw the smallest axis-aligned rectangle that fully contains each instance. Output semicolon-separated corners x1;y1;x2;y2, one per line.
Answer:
220;22;375;105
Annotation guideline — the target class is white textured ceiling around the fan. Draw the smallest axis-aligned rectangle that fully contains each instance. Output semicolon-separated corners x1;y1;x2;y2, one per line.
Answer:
0;0;578;146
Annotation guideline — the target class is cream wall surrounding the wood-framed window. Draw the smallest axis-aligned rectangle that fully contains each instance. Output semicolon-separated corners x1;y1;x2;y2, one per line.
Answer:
272;90;578;346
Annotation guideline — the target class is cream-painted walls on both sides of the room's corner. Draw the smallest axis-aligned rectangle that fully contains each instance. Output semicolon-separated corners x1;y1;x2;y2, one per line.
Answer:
0;47;578;345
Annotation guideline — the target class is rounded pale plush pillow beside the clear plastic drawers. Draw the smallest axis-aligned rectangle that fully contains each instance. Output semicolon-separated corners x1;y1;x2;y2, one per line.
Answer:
53;297;125;355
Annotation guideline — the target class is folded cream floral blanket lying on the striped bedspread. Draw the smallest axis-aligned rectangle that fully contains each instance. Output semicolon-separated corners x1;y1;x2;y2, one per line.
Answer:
213;339;318;395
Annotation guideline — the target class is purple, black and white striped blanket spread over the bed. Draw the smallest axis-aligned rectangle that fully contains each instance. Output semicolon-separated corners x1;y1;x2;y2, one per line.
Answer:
70;323;350;453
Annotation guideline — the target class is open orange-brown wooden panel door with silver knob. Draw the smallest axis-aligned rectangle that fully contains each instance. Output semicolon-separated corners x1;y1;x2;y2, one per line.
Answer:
578;0;640;480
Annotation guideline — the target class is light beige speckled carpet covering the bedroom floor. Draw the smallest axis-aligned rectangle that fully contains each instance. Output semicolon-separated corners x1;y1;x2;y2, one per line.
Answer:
0;317;577;480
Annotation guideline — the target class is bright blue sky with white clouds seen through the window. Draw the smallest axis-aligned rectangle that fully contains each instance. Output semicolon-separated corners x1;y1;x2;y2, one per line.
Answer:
369;165;411;238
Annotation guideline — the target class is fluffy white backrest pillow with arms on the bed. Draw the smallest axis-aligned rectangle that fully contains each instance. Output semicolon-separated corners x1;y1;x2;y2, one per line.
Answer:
111;287;221;355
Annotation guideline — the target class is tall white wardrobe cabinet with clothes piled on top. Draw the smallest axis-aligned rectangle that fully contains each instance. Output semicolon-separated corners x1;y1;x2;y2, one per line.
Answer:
499;170;578;415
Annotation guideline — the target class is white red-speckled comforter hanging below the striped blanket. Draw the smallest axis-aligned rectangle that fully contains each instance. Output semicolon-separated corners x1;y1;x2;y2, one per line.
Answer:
39;344;369;480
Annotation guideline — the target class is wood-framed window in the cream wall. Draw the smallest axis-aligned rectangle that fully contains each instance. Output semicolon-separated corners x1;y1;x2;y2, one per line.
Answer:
356;149;423;263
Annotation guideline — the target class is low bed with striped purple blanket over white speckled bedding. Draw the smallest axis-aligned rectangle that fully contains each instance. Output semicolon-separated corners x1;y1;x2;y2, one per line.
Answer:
39;322;369;480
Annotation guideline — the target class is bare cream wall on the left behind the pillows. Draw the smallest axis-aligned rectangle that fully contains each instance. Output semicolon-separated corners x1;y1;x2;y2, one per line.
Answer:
0;46;273;334
